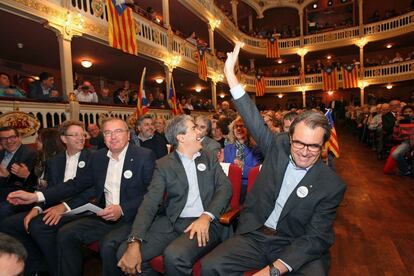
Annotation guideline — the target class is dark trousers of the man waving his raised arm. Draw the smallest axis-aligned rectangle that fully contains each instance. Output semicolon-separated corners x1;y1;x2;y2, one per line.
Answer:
201;231;329;276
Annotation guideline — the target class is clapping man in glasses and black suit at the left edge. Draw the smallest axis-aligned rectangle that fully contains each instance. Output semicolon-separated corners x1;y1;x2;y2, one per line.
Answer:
0;127;36;202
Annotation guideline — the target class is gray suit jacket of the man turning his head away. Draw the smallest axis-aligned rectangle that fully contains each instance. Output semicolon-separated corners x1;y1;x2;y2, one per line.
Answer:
131;151;232;240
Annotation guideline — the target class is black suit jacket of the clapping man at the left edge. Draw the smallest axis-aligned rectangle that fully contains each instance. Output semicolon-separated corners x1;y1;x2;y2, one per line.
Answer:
0;145;36;191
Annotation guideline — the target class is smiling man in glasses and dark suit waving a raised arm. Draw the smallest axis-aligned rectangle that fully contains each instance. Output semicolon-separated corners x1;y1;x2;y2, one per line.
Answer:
202;43;345;276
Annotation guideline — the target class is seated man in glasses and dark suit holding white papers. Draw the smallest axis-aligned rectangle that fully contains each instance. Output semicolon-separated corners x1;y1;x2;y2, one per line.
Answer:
8;117;155;276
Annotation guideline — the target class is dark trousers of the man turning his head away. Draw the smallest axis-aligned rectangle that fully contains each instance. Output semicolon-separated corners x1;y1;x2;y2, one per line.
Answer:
118;218;223;275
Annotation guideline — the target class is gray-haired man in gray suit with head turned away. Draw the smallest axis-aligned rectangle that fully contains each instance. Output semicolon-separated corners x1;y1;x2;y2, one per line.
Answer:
118;115;231;275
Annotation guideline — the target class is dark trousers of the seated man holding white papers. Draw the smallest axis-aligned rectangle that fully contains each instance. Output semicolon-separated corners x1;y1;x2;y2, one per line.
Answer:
57;216;130;276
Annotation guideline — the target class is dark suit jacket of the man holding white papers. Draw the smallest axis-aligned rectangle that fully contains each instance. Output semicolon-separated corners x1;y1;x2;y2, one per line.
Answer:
43;144;155;221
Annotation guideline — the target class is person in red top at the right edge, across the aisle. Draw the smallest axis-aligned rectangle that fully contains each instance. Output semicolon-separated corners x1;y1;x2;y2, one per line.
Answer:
391;105;414;175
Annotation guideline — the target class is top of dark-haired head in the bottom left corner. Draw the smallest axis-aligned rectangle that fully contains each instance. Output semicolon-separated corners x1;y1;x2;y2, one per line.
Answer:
0;233;27;276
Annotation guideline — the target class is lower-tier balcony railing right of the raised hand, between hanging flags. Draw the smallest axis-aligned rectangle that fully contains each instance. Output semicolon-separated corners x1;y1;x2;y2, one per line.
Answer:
241;60;414;92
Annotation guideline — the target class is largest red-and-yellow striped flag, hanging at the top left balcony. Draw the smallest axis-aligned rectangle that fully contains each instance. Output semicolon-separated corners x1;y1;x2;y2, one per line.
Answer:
106;0;137;55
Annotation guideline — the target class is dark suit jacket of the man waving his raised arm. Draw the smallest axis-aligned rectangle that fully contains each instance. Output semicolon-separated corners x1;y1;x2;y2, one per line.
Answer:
235;94;346;270
